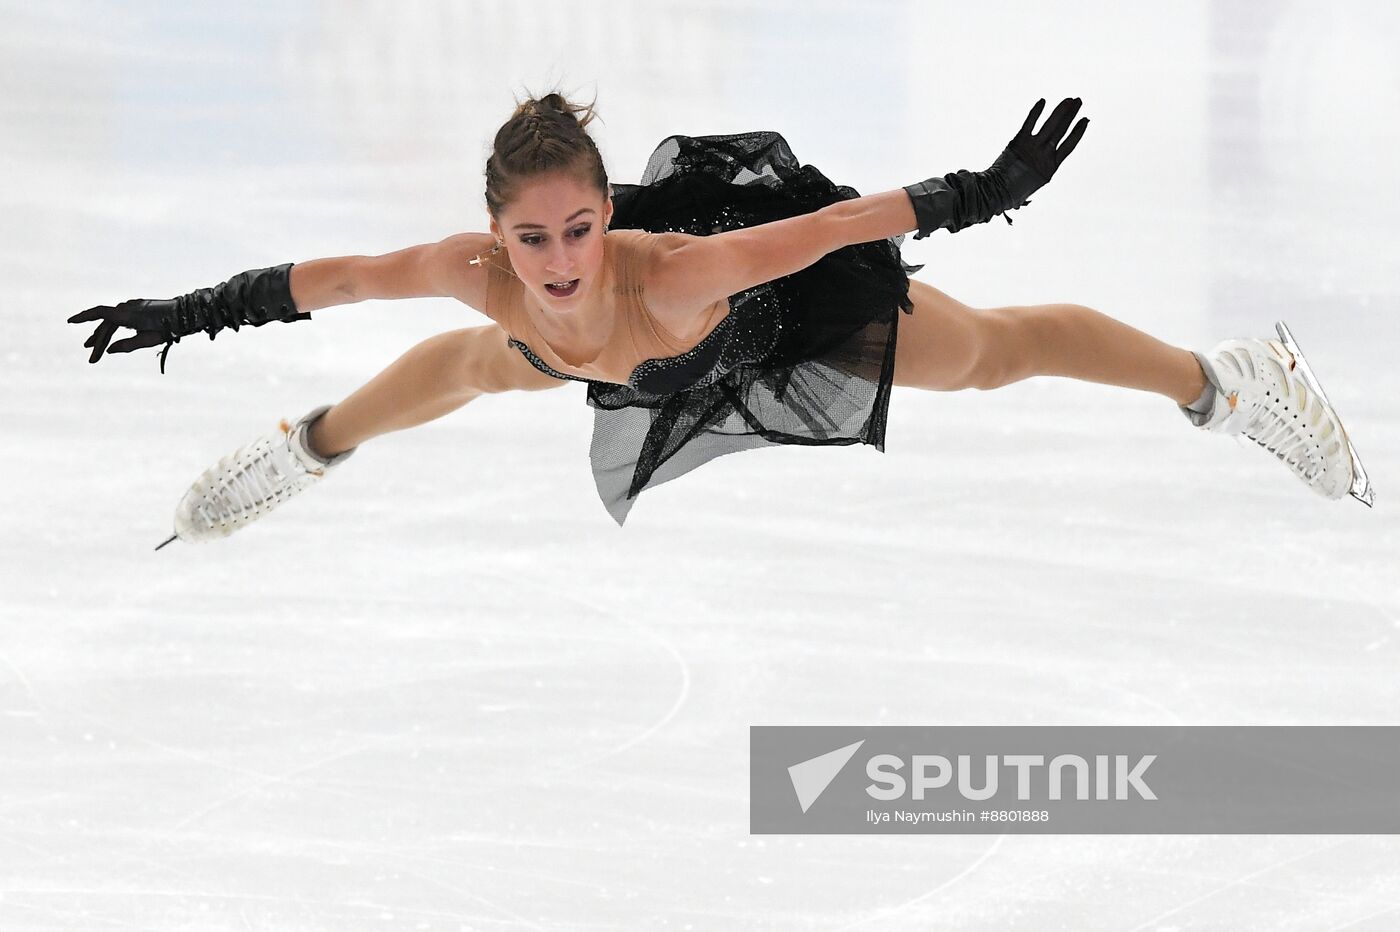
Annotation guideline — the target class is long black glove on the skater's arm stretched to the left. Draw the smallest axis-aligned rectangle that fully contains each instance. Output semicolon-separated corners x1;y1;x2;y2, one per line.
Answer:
69;262;311;375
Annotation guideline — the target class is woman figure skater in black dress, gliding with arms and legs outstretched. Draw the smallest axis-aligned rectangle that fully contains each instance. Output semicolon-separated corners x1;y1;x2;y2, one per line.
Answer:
69;94;1372;550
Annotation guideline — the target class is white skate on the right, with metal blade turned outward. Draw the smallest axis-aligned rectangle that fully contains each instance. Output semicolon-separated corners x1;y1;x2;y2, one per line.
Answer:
1182;320;1375;507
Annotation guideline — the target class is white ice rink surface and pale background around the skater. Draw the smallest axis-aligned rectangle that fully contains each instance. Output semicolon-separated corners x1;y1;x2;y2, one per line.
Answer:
0;0;1400;932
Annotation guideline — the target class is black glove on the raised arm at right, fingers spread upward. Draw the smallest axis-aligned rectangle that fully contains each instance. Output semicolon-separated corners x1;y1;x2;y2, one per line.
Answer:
904;97;1089;239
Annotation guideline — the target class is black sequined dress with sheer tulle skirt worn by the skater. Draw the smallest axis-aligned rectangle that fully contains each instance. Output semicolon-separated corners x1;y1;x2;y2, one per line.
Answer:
588;132;923;525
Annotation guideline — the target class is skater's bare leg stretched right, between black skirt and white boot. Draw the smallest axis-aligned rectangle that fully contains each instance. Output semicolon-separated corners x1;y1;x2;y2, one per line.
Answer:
895;281;1205;404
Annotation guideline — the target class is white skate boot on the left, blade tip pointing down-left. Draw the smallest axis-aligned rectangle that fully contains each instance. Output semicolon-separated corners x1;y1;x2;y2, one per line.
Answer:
155;404;358;550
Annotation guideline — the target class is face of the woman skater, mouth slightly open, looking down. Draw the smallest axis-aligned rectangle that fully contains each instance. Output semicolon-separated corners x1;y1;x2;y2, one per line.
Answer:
491;172;613;313
